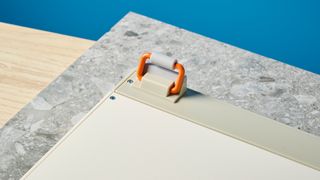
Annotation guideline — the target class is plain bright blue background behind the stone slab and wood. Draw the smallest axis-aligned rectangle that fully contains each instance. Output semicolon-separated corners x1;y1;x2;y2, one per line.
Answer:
0;0;320;74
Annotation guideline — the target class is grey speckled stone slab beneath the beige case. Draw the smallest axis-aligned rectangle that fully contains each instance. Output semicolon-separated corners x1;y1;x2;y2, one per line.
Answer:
0;13;320;179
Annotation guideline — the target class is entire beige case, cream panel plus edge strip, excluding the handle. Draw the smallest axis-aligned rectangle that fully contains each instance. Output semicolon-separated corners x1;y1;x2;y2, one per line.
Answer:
22;71;320;180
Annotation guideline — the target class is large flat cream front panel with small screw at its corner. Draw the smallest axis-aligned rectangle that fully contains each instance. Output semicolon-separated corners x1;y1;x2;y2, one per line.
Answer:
23;93;320;180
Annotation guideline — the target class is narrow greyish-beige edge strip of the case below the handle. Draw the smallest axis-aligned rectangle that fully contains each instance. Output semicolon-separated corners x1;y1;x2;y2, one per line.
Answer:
116;73;320;170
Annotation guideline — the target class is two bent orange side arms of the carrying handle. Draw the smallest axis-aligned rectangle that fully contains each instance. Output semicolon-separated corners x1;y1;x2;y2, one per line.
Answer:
137;53;185;94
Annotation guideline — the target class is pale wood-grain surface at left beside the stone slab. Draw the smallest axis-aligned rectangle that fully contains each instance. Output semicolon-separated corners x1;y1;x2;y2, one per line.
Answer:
0;22;94;128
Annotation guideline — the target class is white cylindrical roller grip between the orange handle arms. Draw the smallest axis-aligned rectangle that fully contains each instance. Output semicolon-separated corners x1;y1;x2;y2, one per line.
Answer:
150;52;177;70
